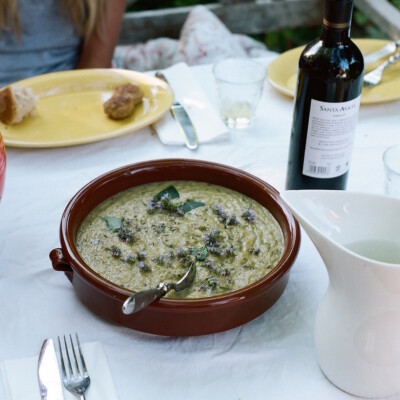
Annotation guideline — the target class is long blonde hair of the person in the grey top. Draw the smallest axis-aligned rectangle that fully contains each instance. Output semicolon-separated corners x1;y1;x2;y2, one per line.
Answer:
0;0;107;38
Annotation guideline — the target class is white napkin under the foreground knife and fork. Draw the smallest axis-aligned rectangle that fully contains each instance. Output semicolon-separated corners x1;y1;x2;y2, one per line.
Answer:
0;342;118;400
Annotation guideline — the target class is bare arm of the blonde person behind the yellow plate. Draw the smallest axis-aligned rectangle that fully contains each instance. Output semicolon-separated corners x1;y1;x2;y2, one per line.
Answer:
76;0;126;68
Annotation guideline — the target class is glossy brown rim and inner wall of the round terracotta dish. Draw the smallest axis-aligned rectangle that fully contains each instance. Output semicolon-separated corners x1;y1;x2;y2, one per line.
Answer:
60;158;300;312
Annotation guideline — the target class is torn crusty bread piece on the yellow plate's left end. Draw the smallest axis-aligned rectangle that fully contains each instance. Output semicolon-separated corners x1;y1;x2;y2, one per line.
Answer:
0;86;38;125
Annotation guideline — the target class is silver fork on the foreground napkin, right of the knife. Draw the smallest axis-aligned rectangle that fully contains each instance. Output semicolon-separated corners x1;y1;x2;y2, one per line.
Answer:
58;333;90;400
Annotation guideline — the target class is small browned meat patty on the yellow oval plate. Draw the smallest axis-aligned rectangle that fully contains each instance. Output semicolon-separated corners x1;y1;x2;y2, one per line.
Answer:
103;83;143;119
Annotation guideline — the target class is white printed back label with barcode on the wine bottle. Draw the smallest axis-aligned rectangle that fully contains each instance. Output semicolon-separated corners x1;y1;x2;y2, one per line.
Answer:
303;95;361;179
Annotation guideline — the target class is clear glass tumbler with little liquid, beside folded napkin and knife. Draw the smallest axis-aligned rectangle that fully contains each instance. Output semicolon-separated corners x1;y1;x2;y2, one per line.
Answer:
213;58;266;129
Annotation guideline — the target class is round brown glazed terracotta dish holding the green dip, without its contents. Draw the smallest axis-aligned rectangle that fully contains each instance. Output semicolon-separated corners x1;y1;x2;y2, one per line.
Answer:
50;159;300;336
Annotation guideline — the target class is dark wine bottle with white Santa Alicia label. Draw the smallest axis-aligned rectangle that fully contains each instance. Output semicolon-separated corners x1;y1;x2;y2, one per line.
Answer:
286;0;364;190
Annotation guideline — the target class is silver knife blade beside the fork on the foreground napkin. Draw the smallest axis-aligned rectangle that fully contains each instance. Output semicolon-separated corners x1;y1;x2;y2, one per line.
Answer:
38;339;64;400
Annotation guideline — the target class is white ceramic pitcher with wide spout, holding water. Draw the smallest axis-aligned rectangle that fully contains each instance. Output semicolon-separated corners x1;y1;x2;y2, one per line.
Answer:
281;190;400;397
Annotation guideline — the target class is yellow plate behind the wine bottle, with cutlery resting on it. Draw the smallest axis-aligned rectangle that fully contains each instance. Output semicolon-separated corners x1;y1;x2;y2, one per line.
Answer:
268;39;400;104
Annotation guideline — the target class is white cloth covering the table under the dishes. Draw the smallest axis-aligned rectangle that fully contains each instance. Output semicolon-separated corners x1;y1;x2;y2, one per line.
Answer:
0;60;400;400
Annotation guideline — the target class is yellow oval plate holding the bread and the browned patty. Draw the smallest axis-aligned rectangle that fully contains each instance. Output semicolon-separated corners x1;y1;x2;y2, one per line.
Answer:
0;69;173;147
